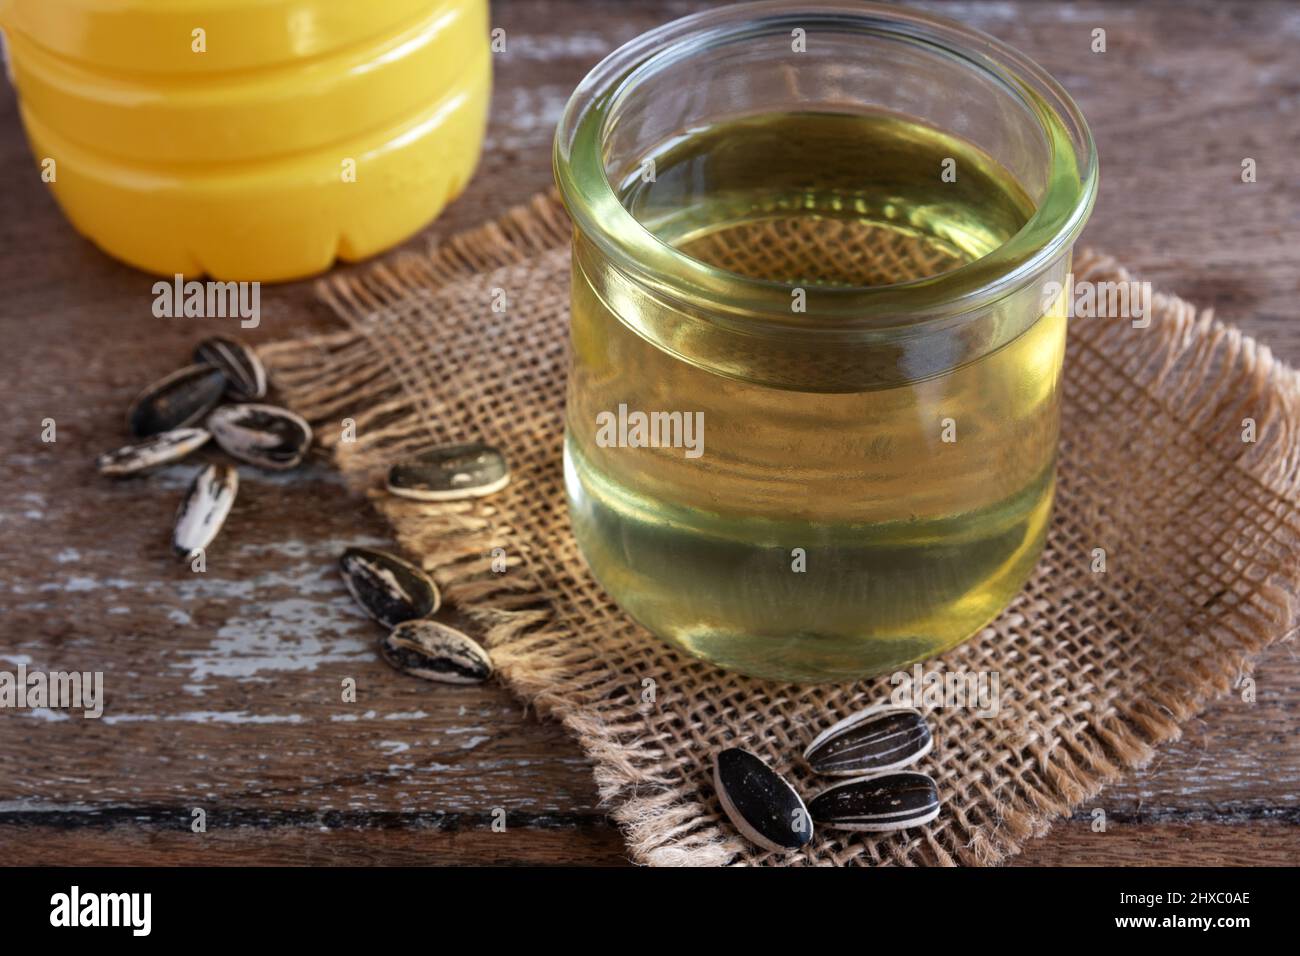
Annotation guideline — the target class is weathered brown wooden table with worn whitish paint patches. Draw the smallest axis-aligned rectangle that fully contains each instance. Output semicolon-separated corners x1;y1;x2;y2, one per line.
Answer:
0;0;1300;865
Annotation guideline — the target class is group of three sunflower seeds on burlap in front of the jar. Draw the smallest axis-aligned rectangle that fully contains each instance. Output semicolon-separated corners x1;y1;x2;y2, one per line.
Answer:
714;705;940;851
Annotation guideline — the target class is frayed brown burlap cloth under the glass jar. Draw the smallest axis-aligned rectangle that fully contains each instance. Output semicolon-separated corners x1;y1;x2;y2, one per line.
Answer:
263;196;1300;864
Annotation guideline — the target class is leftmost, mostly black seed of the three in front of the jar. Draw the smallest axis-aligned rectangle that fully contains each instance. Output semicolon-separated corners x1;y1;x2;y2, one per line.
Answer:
714;747;813;849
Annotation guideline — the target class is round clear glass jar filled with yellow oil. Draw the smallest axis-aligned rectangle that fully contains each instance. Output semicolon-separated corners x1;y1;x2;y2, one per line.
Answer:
555;3;1097;682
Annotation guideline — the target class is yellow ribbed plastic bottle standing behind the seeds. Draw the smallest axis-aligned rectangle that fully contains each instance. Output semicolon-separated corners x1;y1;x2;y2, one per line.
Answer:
0;0;491;281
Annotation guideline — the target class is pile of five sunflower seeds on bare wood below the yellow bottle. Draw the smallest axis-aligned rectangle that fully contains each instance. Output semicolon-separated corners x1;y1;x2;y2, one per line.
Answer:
96;337;312;557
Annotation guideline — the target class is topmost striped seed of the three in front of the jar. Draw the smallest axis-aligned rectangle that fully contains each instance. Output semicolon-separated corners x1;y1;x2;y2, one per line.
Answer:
803;704;935;777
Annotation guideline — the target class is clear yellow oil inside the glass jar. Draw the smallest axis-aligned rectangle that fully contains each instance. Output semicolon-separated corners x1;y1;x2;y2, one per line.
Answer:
566;113;1066;680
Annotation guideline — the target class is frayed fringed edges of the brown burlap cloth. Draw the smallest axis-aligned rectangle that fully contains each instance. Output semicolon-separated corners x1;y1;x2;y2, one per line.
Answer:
261;196;1300;865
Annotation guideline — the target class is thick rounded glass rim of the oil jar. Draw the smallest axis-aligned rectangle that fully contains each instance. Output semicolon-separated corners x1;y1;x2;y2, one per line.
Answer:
554;0;1097;336
